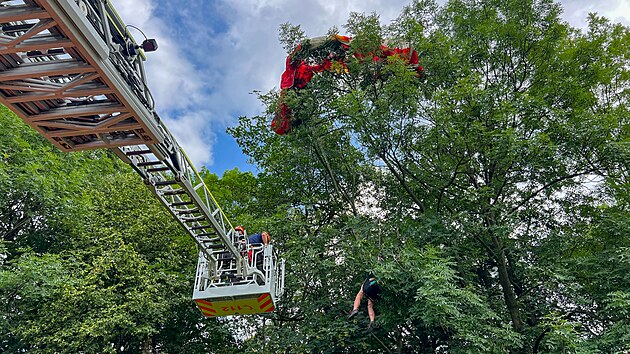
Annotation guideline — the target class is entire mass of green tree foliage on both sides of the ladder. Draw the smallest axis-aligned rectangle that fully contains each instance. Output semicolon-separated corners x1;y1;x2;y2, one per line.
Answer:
0;0;630;353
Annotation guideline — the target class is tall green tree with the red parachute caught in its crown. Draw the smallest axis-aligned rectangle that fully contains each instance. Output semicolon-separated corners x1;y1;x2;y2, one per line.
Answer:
233;0;630;352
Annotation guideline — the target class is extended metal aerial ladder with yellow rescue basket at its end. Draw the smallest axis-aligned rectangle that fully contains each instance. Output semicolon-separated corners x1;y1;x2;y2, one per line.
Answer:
0;0;285;317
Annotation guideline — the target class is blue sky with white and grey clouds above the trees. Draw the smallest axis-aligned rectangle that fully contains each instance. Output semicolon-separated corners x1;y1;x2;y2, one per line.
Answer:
111;0;630;176
